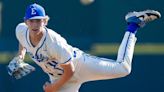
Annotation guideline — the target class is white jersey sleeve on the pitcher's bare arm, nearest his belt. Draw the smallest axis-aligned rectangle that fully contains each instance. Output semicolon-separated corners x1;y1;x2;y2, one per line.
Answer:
47;30;73;63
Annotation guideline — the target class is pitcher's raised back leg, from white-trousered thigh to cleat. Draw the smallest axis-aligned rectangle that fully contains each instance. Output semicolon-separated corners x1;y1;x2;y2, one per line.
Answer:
77;10;160;81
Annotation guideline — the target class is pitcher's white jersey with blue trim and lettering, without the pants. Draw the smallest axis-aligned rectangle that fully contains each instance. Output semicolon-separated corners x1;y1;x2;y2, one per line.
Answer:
16;23;80;78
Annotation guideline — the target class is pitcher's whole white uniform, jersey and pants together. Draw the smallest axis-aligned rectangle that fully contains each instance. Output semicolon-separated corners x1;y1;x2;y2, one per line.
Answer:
16;23;136;92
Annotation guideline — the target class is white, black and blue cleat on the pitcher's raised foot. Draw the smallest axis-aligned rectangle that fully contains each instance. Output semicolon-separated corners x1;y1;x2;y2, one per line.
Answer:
125;10;161;27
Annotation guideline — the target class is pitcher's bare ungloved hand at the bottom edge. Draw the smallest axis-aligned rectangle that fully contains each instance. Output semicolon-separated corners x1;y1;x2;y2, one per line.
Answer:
43;82;57;92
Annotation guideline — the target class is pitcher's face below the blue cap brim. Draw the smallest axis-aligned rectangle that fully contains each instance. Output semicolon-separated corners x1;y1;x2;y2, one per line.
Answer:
25;19;45;33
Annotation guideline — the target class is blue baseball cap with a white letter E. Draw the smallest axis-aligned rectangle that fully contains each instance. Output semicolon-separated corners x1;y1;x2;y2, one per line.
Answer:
24;3;46;20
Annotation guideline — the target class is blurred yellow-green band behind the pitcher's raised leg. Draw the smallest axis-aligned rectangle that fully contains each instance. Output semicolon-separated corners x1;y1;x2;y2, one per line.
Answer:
90;43;164;55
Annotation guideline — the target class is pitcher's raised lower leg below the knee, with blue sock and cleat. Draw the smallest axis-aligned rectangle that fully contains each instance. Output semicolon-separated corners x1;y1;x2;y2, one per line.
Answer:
117;10;161;65
